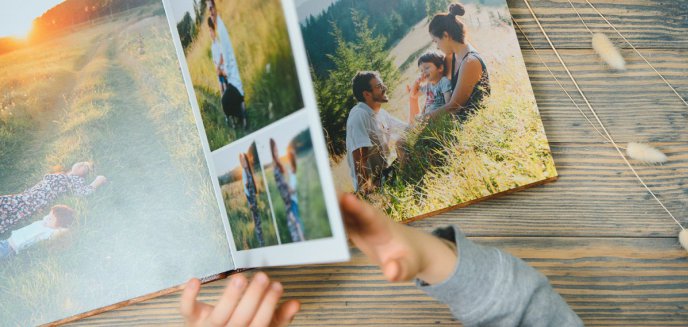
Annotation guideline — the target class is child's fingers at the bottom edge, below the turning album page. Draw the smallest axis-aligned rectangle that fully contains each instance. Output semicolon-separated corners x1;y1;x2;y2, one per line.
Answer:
180;272;300;327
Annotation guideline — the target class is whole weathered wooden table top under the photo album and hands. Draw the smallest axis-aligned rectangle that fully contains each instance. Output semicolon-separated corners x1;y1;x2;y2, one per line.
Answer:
67;0;688;326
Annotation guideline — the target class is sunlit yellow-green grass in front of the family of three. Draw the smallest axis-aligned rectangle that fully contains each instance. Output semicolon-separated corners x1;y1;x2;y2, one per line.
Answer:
366;58;557;221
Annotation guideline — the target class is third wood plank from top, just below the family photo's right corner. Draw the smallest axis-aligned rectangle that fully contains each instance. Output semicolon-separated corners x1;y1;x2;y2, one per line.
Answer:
412;143;688;237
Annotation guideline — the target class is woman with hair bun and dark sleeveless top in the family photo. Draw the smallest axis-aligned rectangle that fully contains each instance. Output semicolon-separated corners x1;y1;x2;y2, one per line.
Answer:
428;3;490;121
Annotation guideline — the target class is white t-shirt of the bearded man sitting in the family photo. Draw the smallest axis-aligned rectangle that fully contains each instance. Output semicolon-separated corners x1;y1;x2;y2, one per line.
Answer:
346;102;408;191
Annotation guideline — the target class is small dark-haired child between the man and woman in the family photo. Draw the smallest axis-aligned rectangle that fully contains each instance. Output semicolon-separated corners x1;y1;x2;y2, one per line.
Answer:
406;51;452;123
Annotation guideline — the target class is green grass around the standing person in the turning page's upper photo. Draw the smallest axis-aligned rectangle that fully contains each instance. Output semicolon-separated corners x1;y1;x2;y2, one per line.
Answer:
186;0;303;150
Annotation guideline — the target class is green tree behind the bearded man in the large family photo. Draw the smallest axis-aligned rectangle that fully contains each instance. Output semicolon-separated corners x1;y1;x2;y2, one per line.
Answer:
313;12;400;157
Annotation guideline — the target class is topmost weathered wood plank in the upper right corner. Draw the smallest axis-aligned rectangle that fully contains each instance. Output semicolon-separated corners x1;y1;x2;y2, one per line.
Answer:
507;0;688;50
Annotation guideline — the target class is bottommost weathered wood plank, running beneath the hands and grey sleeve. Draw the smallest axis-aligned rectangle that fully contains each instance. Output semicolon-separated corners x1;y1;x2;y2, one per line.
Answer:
68;237;688;326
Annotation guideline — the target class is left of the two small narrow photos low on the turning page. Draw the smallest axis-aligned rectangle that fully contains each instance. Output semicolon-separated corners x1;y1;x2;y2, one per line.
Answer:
213;143;279;251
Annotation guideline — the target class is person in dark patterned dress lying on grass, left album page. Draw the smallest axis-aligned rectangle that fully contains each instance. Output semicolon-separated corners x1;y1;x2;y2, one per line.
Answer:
0;162;107;234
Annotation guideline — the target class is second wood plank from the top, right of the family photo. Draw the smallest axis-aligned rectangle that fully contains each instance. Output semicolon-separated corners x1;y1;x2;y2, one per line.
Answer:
523;48;688;143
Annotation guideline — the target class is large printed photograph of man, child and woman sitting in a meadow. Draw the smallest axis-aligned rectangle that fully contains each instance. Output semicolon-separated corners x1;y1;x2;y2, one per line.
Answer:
296;0;557;221
